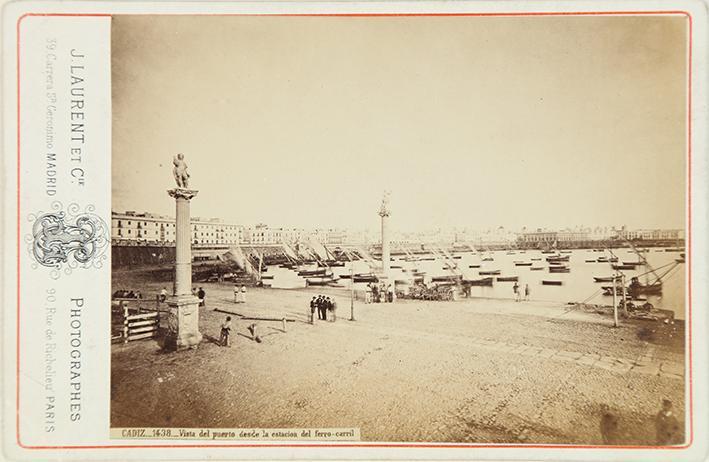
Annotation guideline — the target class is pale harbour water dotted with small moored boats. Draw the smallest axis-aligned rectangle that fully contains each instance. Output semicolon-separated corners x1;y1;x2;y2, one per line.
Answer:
268;249;686;319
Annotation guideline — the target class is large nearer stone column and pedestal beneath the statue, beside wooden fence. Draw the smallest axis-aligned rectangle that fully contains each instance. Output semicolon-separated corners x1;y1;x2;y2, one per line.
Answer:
166;188;202;350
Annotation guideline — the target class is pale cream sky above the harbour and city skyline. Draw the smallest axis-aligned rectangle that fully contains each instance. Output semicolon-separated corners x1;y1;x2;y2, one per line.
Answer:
112;16;687;231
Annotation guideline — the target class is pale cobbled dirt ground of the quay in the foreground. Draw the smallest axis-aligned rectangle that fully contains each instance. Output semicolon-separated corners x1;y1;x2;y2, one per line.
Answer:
111;274;685;445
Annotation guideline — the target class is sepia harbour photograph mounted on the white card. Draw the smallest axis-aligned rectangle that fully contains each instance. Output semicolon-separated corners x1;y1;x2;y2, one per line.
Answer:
110;14;691;447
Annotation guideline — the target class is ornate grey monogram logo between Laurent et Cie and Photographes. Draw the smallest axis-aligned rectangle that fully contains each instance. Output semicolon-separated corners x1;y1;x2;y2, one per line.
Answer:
26;202;110;279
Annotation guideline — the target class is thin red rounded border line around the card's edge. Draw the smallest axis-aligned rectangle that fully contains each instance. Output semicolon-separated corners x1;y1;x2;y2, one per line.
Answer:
15;10;694;450
